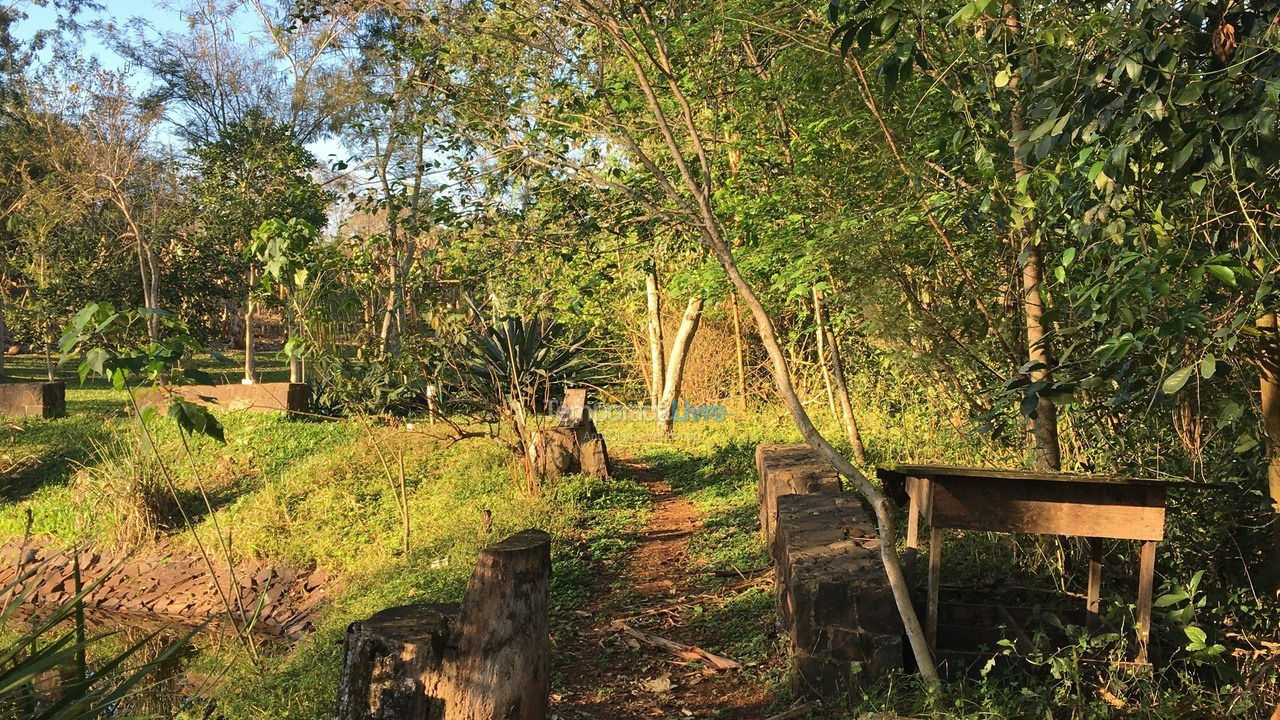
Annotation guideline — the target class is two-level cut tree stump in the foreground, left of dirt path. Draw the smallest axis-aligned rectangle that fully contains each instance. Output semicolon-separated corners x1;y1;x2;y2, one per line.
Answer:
338;530;552;720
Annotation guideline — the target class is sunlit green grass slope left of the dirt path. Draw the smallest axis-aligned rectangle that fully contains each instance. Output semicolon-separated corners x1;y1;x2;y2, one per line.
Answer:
0;357;649;720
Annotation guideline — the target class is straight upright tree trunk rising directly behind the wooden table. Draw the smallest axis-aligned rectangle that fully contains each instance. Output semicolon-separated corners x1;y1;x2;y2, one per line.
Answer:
1005;0;1062;470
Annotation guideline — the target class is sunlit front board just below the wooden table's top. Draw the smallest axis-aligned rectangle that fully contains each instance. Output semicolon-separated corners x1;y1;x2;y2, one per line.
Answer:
927;475;1165;541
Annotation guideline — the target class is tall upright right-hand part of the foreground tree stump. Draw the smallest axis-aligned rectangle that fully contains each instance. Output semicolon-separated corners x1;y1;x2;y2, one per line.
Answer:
440;530;552;720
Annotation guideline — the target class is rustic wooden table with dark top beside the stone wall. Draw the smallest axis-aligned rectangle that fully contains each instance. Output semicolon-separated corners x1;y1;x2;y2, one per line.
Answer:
877;465;1216;662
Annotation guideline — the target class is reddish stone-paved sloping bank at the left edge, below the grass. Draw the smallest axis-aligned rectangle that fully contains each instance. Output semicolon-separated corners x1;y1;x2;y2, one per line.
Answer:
0;542;332;637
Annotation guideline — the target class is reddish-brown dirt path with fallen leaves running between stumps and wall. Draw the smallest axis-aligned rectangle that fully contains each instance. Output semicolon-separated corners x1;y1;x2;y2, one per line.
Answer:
552;462;772;720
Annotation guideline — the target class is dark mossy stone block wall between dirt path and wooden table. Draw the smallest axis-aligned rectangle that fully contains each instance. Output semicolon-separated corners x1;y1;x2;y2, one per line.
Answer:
756;446;902;697
